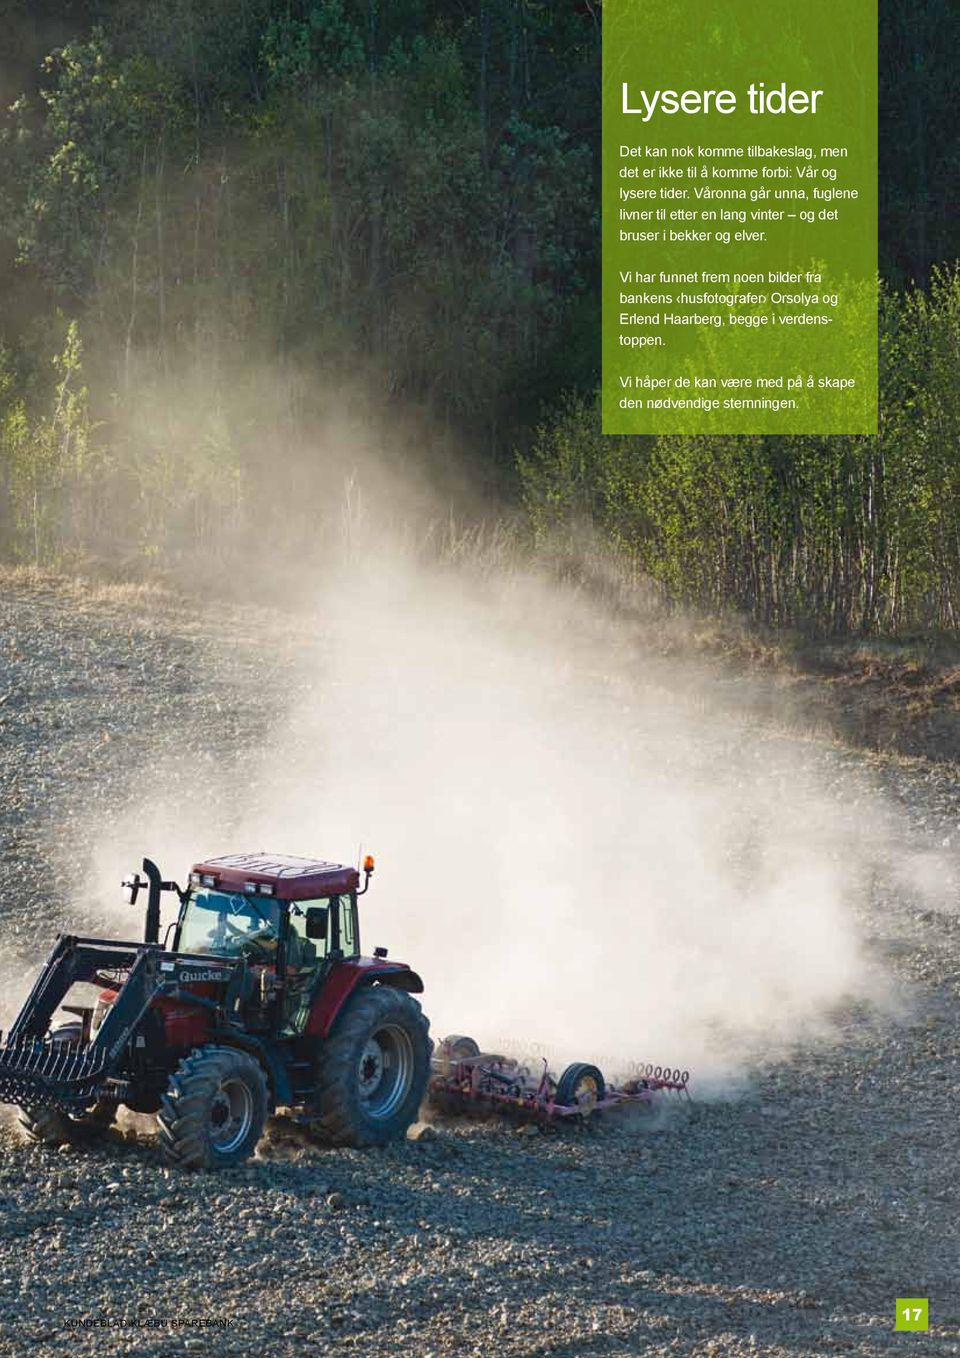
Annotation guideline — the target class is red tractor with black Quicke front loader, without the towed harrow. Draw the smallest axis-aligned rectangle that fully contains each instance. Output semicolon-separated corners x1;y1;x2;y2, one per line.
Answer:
0;853;432;1168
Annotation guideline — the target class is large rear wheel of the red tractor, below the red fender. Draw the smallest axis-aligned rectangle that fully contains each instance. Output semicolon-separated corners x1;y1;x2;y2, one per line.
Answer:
308;986;432;1146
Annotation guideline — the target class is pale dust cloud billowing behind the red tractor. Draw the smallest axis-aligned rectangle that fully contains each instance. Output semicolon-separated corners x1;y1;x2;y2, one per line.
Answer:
77;439;907;1078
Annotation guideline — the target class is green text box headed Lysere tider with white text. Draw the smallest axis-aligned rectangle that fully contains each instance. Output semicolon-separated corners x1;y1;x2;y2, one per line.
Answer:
603;0;877;433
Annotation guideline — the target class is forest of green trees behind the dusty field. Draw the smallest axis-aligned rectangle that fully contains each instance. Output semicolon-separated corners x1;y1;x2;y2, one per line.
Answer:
0;0;960;636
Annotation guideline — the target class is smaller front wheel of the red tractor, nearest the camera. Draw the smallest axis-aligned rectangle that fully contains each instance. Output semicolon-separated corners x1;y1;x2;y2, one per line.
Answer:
156;1046;267;1169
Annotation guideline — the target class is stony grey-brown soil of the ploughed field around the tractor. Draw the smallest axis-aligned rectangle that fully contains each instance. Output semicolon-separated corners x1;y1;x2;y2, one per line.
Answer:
0;583;960;1358
